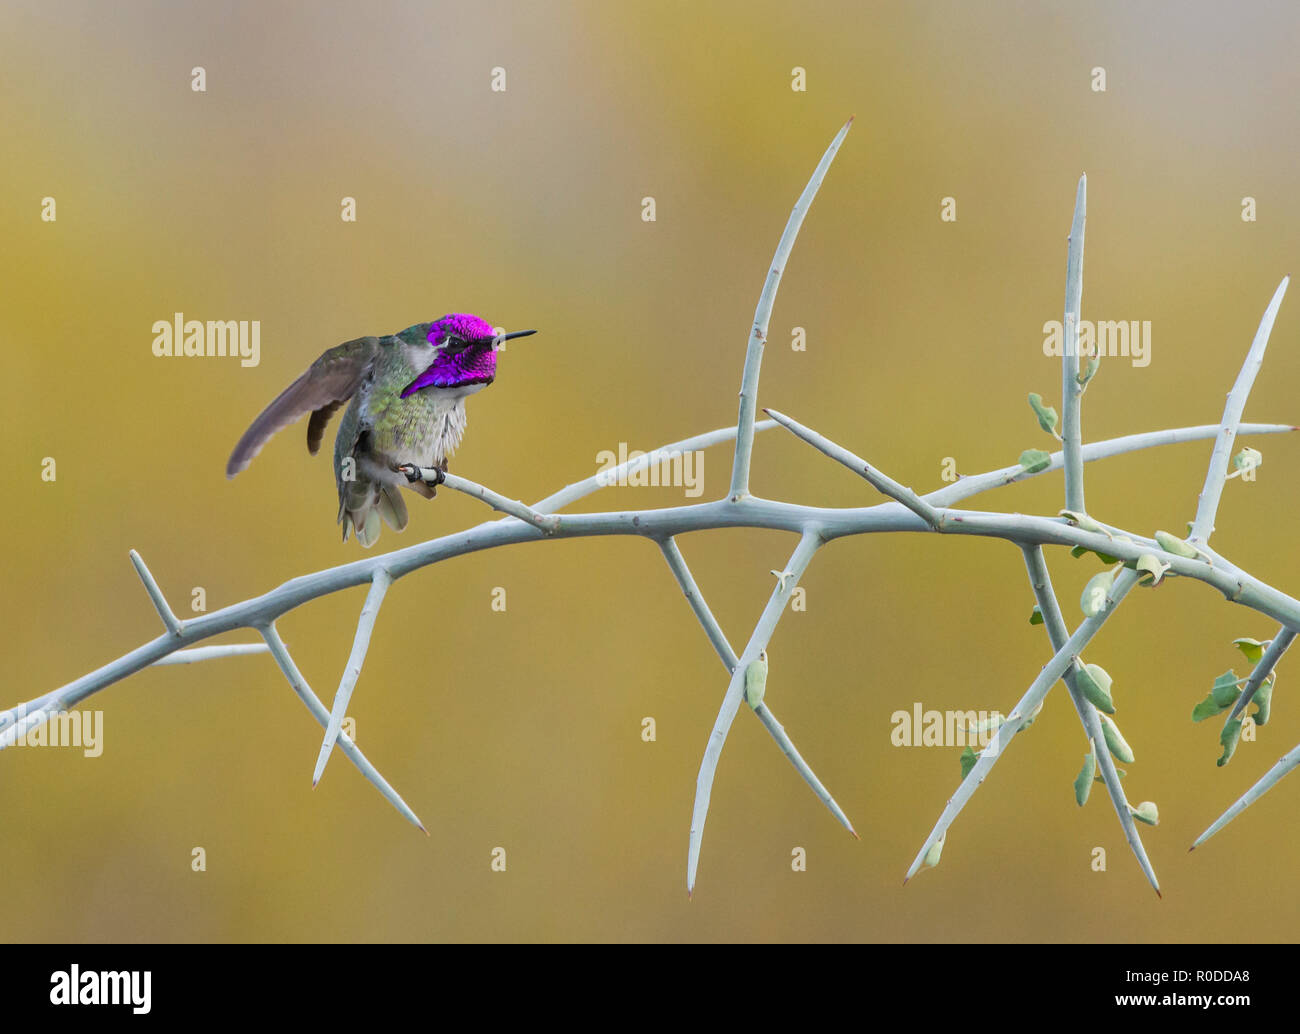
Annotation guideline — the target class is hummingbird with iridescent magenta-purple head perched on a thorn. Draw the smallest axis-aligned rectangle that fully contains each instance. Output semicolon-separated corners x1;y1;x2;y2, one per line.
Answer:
226;312;537;548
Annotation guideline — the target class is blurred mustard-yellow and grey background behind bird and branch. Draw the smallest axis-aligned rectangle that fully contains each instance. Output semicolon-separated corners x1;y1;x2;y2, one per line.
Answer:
0;0;1300;940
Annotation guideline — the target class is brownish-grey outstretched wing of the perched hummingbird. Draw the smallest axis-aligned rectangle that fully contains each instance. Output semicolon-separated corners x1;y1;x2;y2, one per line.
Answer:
226;337;380;477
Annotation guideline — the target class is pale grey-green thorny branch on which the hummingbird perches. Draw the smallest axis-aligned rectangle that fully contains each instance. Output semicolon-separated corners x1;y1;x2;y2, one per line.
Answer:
0;120;1300;892
